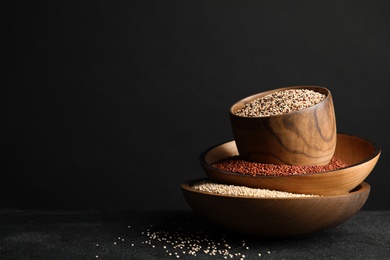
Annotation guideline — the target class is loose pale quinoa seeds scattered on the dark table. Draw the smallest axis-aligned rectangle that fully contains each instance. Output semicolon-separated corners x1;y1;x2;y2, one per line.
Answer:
94;217;270;260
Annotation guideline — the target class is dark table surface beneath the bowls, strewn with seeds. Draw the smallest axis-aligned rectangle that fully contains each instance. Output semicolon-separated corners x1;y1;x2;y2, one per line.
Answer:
0;210;390;259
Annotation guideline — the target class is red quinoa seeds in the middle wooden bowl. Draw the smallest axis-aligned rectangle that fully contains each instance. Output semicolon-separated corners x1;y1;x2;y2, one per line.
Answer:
211;156;347;176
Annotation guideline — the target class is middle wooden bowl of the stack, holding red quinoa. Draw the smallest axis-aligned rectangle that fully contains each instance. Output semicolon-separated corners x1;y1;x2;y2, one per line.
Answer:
200;134;381;195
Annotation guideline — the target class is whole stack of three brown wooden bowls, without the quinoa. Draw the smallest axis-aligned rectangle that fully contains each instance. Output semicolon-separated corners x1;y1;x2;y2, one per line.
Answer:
181;86;381;237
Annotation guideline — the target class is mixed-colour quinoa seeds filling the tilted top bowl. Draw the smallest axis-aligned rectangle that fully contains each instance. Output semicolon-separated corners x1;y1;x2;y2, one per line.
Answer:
234;89;326;117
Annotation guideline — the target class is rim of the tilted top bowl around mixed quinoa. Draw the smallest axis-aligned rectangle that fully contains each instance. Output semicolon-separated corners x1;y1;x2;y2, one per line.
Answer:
229;85;332;120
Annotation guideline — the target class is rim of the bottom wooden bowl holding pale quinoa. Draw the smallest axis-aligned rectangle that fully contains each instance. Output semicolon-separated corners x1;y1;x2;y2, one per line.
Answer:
180;177;371;201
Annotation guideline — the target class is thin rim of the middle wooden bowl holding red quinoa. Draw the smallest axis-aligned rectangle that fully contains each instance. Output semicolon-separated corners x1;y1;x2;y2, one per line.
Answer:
199;133;382;178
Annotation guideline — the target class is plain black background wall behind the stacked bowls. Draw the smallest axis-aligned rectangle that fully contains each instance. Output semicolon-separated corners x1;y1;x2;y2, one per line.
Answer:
0;0;390;209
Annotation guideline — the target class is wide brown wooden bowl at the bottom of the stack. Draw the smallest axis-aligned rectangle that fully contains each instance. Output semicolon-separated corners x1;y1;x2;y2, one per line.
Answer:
181;180;370;237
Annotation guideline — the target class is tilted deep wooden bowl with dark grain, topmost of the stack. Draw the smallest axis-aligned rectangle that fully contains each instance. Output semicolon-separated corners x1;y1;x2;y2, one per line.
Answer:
230;86;337;165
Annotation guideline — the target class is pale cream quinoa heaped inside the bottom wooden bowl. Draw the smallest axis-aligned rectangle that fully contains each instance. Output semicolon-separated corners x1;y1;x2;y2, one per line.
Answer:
192;180;320;198
